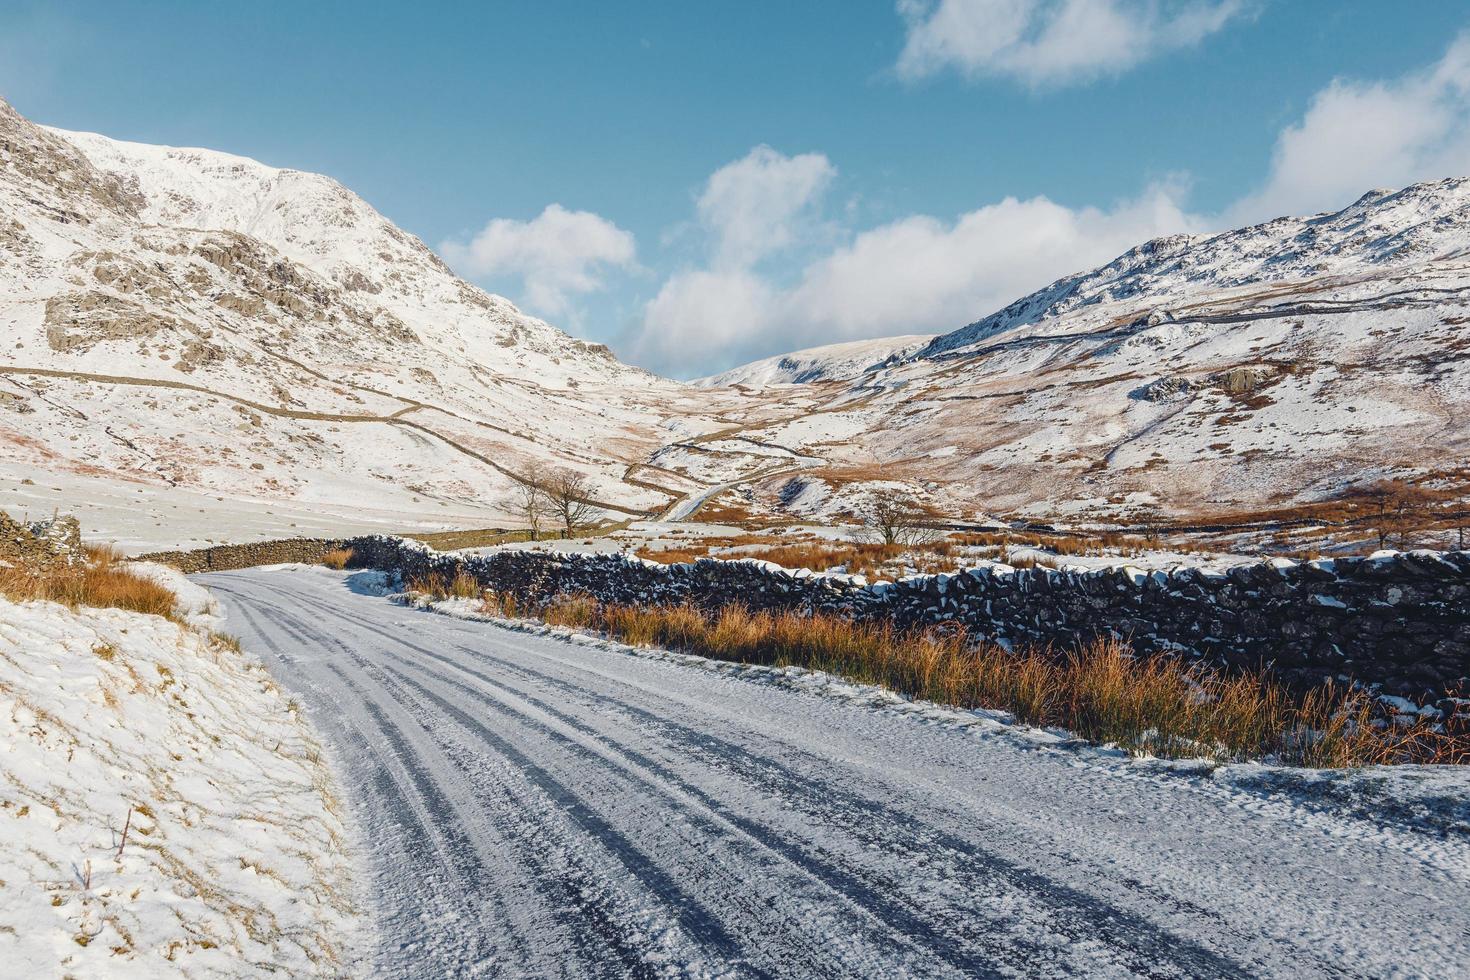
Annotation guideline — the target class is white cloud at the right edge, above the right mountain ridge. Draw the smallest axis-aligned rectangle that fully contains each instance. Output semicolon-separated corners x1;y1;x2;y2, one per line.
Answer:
1226;34;1470;225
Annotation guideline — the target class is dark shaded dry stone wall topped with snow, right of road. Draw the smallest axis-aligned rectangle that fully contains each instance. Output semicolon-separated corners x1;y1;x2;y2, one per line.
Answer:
345;536;1470;701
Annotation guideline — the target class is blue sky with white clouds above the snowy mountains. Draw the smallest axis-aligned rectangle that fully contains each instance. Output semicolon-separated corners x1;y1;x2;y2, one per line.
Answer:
0;0;1470;376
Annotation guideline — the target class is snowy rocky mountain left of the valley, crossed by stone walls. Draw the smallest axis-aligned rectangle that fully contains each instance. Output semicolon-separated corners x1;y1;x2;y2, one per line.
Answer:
0;103;740;544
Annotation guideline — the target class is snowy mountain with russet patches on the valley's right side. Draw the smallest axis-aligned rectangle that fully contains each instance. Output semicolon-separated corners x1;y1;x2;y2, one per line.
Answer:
696;178;1470;523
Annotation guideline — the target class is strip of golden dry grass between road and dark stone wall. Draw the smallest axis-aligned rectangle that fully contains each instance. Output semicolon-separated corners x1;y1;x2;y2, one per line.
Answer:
502;594;1470;768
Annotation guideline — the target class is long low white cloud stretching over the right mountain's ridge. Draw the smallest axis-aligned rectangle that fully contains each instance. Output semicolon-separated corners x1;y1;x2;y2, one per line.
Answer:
625;176;1200;373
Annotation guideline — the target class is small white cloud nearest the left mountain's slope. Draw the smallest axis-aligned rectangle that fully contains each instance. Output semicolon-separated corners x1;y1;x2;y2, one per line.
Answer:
441;204;637;316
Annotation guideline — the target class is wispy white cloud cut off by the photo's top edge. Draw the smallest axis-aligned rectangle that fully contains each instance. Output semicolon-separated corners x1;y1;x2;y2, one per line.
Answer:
898;0;1252;87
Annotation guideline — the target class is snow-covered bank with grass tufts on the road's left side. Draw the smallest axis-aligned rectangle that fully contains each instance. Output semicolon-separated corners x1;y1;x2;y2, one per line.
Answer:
0;587;360;977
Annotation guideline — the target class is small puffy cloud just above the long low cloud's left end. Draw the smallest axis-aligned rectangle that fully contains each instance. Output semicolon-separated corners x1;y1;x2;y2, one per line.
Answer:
697;145;836;269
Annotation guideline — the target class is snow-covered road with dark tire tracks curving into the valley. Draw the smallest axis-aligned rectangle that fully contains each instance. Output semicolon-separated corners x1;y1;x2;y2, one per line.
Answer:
201;569;1470;977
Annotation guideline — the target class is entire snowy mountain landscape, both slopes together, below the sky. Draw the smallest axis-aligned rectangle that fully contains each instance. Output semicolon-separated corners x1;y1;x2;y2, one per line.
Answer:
0;92;1470;548
